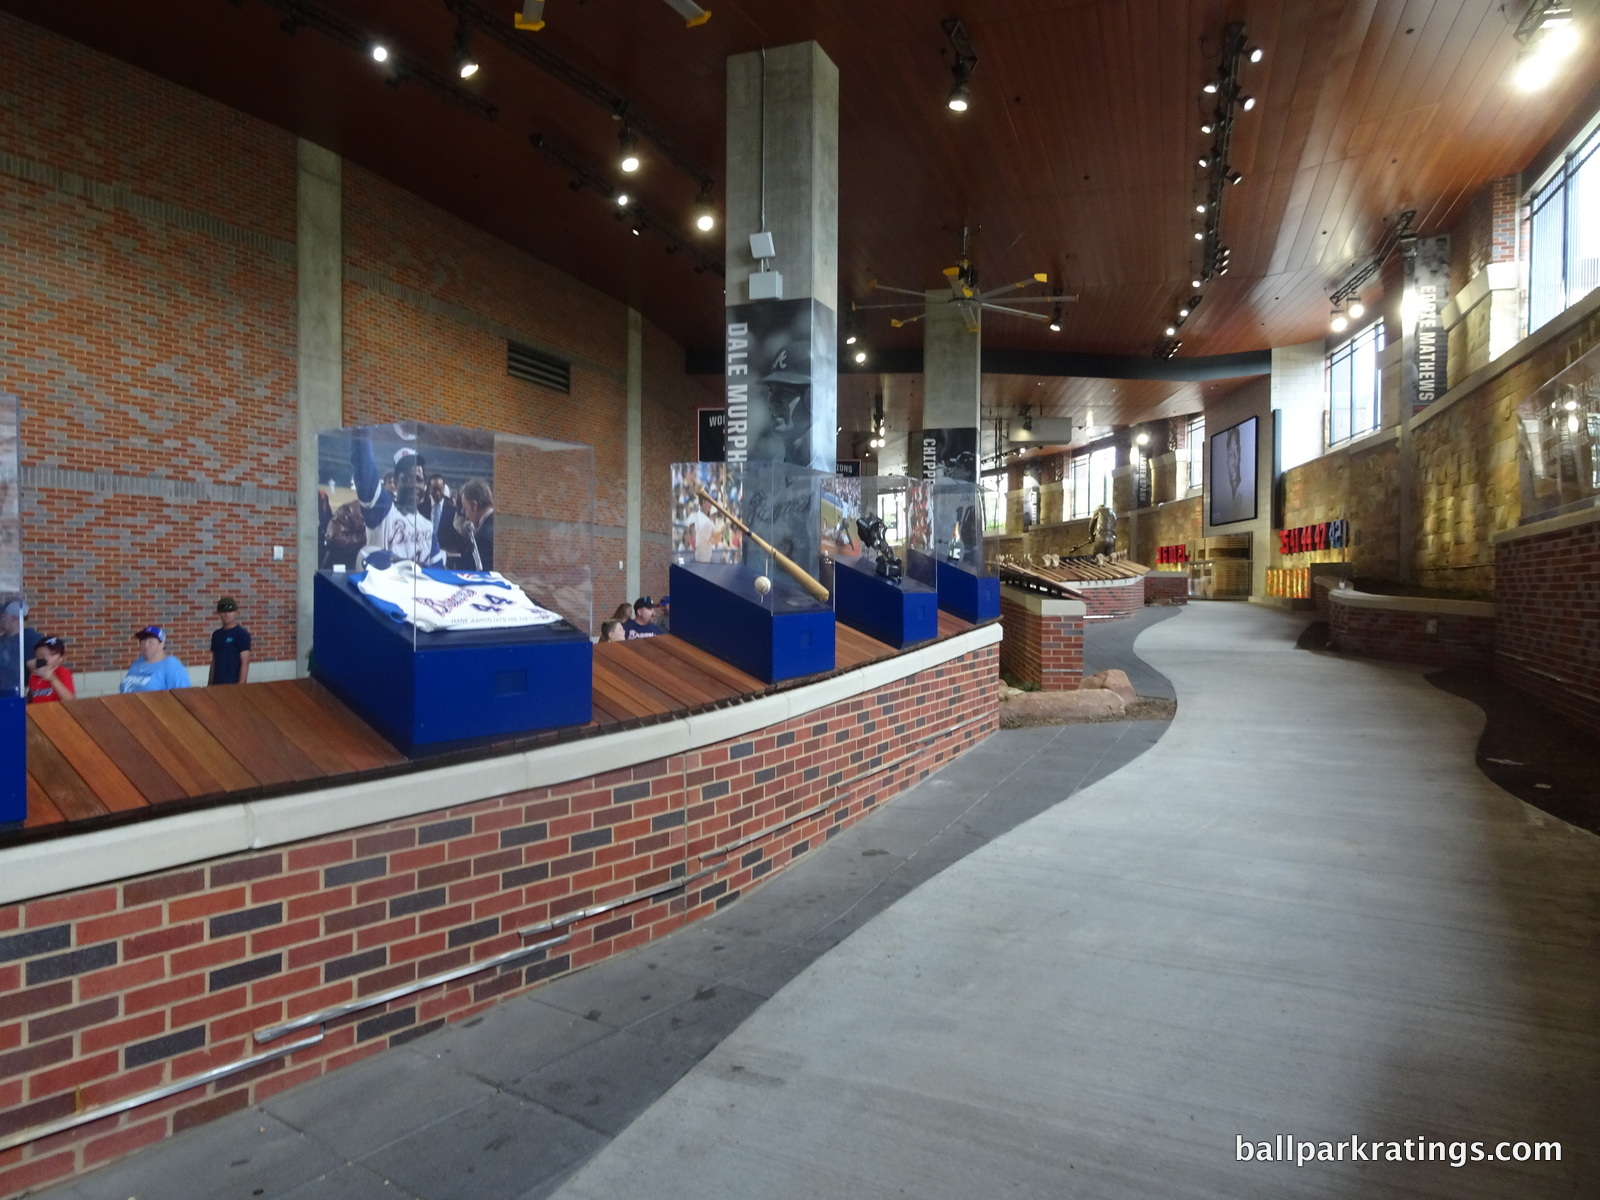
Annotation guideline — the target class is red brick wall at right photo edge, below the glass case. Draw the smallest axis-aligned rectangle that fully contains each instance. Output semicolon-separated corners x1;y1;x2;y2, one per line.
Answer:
1494;522;1600;731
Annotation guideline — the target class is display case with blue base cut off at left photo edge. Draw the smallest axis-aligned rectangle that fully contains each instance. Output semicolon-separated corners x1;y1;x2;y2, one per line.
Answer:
0;395;23;824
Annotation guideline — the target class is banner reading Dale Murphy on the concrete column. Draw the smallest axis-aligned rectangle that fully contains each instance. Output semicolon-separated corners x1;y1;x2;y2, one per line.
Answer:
725;298;838;475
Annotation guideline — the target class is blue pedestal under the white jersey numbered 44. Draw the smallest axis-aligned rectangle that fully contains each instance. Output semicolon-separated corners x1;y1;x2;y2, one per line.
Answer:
312;571;594;754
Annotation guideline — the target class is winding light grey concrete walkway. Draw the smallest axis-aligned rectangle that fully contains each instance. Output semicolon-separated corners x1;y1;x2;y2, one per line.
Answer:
557;605;1600;1200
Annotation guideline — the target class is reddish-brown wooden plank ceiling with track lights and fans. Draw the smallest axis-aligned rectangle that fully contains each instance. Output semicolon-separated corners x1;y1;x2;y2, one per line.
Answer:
0;0;1600;402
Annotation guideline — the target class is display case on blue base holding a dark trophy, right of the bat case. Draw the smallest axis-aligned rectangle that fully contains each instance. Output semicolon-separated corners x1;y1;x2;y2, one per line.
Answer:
822;475;939;650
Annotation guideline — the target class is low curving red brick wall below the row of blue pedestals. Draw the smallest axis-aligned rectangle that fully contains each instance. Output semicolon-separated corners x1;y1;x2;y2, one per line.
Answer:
0;646;997;1195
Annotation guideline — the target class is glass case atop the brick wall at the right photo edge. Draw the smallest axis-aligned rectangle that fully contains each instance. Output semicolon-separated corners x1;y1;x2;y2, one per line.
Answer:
1517;347;1600;522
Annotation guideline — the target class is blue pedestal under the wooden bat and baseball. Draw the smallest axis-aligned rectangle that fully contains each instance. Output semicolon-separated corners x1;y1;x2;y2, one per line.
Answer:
670;563;834;683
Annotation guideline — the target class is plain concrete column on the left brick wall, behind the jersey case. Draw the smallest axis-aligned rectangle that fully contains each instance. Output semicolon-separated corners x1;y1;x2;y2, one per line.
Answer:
294;141;344;674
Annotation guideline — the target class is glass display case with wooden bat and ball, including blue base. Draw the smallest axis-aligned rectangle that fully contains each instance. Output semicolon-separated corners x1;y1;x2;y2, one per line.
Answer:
670;462;837;683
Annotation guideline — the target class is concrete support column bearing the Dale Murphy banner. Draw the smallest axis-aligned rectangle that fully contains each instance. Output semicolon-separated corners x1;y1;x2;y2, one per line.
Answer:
726;42;838;474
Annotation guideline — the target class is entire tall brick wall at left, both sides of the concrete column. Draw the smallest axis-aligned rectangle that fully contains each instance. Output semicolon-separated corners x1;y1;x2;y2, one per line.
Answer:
0;13;714;670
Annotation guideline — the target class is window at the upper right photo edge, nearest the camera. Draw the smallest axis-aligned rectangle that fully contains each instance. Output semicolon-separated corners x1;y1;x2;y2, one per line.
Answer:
1528;120;1600;333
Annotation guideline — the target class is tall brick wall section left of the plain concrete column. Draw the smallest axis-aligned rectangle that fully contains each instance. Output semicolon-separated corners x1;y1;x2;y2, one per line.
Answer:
0;14;296;670
